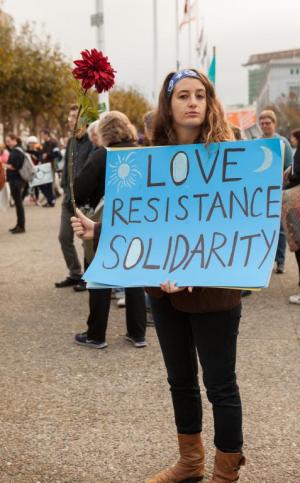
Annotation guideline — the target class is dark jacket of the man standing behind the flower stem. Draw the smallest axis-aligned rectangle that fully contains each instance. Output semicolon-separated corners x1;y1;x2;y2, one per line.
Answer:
61;134;93;207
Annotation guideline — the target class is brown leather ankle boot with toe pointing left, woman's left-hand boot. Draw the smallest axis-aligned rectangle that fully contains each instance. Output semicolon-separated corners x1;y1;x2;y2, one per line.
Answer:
146;433;204;483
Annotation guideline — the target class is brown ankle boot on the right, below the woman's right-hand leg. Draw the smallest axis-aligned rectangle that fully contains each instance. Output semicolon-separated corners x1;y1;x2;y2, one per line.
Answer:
209;449;246;483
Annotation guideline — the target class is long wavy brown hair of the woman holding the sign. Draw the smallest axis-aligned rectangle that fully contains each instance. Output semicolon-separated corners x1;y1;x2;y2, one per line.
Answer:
152;69;234;146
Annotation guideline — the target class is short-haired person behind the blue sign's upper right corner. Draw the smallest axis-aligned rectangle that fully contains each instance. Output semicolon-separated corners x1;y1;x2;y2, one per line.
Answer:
258;110;293;274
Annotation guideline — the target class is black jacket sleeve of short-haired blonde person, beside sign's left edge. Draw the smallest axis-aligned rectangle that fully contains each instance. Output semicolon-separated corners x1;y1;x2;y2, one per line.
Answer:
74;148;106;206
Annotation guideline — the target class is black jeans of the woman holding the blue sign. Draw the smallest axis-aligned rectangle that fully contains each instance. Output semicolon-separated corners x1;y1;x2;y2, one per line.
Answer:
151;295;243;452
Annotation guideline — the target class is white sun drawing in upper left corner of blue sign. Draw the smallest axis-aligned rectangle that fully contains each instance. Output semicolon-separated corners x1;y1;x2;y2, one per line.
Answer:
108;152;142;192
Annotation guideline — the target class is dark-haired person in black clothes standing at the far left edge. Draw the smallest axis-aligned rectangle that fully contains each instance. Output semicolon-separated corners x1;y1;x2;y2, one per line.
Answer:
5;133;25;235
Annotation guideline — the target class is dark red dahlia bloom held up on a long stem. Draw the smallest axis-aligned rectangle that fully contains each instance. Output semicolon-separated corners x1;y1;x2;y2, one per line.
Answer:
72;49;116;94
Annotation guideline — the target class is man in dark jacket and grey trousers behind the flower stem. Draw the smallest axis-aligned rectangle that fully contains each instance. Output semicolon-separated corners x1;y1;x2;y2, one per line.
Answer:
55;105;93;288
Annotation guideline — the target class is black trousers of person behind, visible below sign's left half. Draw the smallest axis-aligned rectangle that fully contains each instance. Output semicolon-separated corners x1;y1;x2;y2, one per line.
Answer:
87;288;146;342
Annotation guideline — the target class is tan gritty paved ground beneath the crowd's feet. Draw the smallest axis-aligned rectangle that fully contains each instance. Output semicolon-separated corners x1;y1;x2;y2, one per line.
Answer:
0;199;300;483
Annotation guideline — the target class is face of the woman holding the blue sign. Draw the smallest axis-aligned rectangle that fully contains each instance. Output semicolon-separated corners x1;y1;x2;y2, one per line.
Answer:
171;77;207;130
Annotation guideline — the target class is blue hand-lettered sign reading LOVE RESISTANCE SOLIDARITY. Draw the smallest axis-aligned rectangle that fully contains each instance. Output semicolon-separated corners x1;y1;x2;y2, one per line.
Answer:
84;139;282;288
